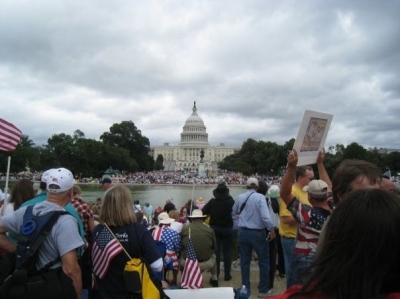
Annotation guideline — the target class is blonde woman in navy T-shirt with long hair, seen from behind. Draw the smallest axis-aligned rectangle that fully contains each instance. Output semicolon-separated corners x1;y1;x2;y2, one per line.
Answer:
92;185;163;299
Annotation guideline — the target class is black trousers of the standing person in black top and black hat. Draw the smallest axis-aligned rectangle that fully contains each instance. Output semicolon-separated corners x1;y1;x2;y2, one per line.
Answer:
210;225;233;278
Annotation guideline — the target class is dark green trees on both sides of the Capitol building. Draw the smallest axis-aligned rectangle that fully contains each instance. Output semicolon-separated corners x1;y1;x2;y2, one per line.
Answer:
0;121;400;177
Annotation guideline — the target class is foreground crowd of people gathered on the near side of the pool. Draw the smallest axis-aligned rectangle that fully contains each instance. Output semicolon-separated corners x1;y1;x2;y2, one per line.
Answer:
0;154;400;299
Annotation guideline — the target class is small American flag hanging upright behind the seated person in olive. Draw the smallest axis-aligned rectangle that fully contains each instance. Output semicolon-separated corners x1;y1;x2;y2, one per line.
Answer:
181;238;203;289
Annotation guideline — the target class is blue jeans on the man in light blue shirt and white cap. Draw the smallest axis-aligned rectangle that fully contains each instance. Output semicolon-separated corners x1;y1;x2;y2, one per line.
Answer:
239;227;269;293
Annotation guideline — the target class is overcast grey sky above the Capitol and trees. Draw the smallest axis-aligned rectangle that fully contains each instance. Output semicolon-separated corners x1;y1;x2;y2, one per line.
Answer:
0;0;400;149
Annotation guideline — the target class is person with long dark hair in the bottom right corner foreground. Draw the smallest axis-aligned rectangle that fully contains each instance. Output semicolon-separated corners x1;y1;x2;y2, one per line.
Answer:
275;189;400;299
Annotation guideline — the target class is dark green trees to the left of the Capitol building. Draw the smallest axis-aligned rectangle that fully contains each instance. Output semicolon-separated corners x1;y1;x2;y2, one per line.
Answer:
0;121;154;177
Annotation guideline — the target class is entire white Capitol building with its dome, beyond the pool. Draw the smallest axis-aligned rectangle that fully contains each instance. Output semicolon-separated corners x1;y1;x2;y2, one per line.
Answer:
150;102;240;172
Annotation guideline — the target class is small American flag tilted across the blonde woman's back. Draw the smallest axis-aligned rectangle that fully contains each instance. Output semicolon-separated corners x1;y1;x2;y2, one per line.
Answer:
92;226;123;279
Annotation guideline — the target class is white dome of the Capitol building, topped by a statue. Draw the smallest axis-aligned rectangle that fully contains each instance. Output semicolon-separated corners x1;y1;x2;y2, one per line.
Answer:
180;102;208;145
